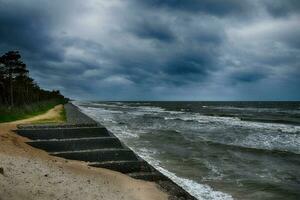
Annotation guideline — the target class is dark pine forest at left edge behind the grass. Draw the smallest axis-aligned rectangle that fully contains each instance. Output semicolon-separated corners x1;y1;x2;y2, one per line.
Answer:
0;51;65;107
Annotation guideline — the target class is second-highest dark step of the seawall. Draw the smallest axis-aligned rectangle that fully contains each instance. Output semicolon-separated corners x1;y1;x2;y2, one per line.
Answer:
27;137;123;152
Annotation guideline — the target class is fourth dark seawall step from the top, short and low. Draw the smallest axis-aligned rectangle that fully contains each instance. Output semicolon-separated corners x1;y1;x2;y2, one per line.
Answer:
89;160;155;173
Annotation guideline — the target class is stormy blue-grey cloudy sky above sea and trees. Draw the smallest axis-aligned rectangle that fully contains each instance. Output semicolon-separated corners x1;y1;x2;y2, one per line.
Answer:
0;0;300;100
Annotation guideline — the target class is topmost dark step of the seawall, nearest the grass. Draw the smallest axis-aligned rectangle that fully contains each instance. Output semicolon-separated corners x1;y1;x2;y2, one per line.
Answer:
16;127;111;140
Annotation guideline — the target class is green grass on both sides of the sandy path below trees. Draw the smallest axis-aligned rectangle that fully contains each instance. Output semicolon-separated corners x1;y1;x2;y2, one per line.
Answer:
0;100;66;123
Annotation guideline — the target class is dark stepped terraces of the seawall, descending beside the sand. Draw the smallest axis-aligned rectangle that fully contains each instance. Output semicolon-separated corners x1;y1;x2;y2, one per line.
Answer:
17;126;164;181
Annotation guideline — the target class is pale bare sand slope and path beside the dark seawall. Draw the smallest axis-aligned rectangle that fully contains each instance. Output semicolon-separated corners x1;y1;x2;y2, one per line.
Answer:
0;106;168;200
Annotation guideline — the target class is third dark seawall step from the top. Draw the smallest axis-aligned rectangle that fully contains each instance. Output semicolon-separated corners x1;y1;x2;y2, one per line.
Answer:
50;149;138;162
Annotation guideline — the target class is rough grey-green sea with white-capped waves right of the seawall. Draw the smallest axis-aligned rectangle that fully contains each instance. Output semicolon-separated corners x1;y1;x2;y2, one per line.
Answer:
75;102;300;200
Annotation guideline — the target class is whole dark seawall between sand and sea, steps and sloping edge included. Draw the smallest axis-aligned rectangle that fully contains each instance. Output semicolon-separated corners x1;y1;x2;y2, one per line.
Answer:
17;103;196;200
